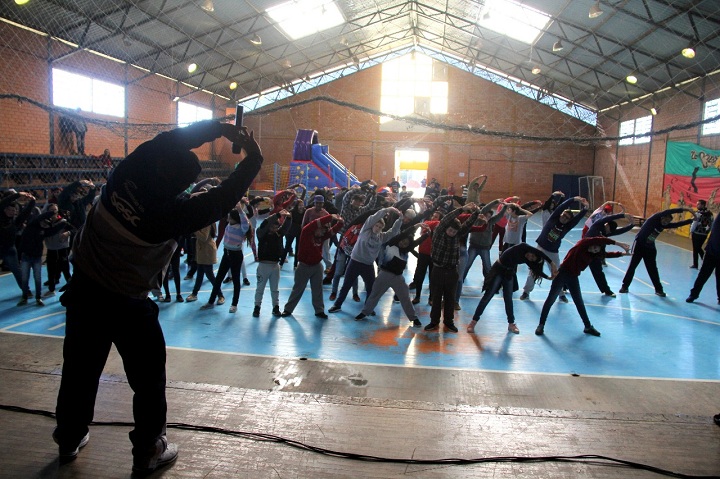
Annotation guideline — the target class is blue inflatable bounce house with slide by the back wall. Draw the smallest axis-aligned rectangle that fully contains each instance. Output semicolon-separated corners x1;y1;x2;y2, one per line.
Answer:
288;130;360;191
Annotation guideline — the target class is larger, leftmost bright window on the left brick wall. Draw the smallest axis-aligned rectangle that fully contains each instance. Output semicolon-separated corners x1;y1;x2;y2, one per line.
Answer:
52;68;125;117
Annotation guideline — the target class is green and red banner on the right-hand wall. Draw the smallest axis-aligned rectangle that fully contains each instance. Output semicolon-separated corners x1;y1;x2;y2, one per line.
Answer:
663;141;720;236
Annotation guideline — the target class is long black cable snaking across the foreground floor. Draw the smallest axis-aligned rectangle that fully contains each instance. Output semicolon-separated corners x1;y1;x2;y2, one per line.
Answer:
0;404;719;479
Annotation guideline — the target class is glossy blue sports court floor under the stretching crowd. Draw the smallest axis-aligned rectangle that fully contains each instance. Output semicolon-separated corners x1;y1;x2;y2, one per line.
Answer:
0;221;720;380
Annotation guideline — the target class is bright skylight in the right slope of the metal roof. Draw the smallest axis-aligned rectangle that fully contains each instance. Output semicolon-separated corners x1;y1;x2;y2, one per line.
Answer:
478;0;550;45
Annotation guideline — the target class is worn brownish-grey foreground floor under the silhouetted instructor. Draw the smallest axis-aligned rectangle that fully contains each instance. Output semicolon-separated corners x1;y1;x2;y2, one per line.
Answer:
0;334;720;478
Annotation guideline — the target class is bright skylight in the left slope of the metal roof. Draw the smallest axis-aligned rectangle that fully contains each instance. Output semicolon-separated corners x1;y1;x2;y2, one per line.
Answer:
266;0;345;40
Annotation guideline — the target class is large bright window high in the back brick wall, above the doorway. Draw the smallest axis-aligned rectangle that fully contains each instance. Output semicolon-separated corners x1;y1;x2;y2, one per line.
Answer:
380;53;448;123
